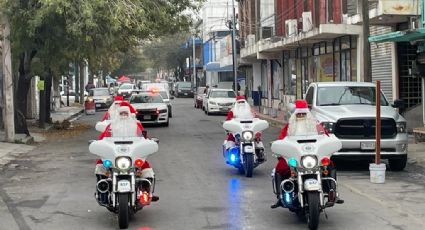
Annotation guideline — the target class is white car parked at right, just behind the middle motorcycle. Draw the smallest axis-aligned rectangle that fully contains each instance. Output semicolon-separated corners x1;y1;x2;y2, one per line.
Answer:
203;89;236;115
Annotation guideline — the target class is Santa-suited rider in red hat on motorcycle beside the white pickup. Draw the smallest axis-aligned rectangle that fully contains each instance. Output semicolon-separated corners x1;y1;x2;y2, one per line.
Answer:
271;100;342;208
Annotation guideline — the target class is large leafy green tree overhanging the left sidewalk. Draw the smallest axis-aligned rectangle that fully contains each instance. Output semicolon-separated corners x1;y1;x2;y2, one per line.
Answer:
0;0;199;132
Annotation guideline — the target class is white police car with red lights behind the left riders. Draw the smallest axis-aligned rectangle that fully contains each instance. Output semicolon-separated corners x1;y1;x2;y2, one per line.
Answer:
130;91;170;126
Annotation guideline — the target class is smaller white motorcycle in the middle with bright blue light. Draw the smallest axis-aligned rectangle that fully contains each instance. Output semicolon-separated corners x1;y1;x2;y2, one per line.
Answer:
223;118;269;177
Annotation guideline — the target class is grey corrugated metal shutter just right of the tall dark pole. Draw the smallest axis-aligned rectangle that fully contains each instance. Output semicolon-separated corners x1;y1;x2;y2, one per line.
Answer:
370;26;393;102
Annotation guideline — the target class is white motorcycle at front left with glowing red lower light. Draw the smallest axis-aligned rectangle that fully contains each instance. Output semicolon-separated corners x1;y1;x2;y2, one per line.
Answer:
89;137;158;228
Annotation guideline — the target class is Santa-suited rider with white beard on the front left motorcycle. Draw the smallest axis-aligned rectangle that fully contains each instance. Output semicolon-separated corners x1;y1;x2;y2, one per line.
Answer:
95;106;159;201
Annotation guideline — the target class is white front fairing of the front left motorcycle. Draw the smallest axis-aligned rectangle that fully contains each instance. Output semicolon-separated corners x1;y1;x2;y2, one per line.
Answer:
89;137;158;164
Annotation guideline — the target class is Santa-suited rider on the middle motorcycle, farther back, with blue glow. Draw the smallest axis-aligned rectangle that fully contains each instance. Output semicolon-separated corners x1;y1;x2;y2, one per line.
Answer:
225;96;265;161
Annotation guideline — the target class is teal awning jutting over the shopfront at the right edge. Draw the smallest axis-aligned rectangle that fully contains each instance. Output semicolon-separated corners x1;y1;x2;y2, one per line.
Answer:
369;28;425;42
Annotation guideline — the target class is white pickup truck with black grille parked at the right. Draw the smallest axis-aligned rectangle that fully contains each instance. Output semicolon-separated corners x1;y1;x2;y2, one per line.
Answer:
305;82;408;171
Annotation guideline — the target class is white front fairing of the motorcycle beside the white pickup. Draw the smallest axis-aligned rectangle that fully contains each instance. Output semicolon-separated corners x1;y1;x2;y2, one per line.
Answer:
271;135;342;162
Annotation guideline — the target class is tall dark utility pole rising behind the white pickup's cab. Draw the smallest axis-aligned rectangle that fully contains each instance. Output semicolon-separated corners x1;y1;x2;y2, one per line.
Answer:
362;0;372;82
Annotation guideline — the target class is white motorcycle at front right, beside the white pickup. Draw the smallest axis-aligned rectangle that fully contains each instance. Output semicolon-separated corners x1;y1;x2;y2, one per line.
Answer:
271;135;343;229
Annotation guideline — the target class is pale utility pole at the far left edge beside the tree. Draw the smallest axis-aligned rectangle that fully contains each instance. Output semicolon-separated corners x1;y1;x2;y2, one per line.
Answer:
1;14;15;142
